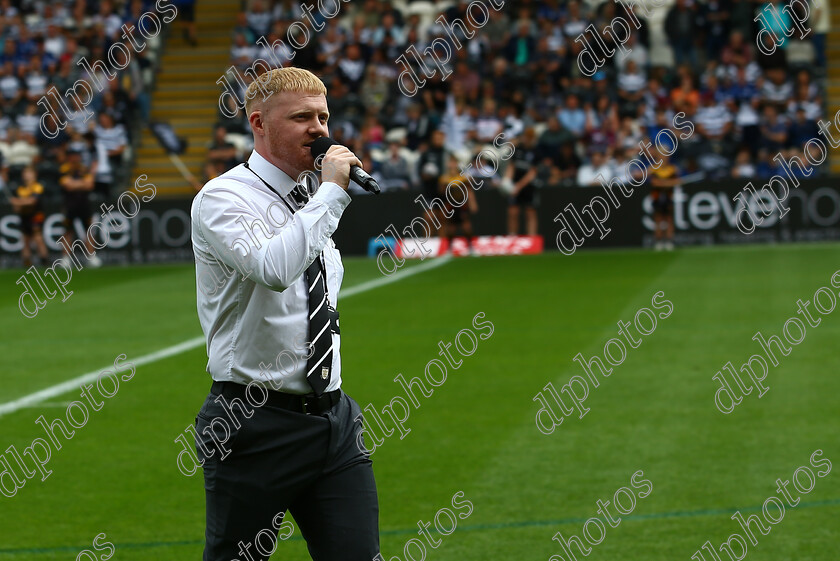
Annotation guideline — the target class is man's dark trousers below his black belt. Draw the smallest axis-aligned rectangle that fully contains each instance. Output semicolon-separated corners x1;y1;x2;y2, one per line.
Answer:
196;384;379;561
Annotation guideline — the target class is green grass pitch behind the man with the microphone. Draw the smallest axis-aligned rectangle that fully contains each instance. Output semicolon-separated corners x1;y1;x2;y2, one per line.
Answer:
0;244;840;561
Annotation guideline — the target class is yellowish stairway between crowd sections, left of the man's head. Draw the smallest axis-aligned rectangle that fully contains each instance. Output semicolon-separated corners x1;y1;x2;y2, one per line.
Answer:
132;0;239;197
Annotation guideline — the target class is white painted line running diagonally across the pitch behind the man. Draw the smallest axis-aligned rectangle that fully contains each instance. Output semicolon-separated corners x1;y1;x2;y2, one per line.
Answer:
0;256;451;417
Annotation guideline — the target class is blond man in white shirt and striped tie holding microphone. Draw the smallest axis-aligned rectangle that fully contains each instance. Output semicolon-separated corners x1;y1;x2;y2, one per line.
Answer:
191;68;379;561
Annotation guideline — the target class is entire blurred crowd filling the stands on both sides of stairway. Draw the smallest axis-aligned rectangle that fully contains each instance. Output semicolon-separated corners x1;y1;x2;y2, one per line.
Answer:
0;0;830;264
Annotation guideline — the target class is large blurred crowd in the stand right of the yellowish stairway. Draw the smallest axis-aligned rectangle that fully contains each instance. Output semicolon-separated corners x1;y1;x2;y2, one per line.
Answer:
213;0;829;200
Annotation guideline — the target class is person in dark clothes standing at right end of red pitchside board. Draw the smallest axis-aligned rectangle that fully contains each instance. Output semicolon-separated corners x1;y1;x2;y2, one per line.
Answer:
505;127;540;236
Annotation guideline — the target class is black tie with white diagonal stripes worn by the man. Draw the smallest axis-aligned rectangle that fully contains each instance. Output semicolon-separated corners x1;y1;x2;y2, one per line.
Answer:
291;185;332;395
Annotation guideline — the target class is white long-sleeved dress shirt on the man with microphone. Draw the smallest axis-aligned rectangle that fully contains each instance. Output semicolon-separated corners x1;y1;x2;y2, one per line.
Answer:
191;152;350;394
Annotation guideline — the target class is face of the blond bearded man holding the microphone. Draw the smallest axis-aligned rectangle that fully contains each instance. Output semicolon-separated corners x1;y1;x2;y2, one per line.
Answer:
251;92;330;179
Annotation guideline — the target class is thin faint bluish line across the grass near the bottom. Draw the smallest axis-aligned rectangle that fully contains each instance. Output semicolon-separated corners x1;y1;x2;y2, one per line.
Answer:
0;499;840;555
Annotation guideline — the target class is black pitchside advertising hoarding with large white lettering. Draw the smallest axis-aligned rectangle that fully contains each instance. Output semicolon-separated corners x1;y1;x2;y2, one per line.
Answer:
0;177;840;268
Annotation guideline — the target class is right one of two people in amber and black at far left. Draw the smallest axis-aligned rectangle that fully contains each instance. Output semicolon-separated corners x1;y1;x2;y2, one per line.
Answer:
59;148;102;268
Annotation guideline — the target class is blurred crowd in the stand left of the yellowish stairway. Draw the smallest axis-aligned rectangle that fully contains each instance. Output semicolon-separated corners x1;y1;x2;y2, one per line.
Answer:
0;0;159;199
